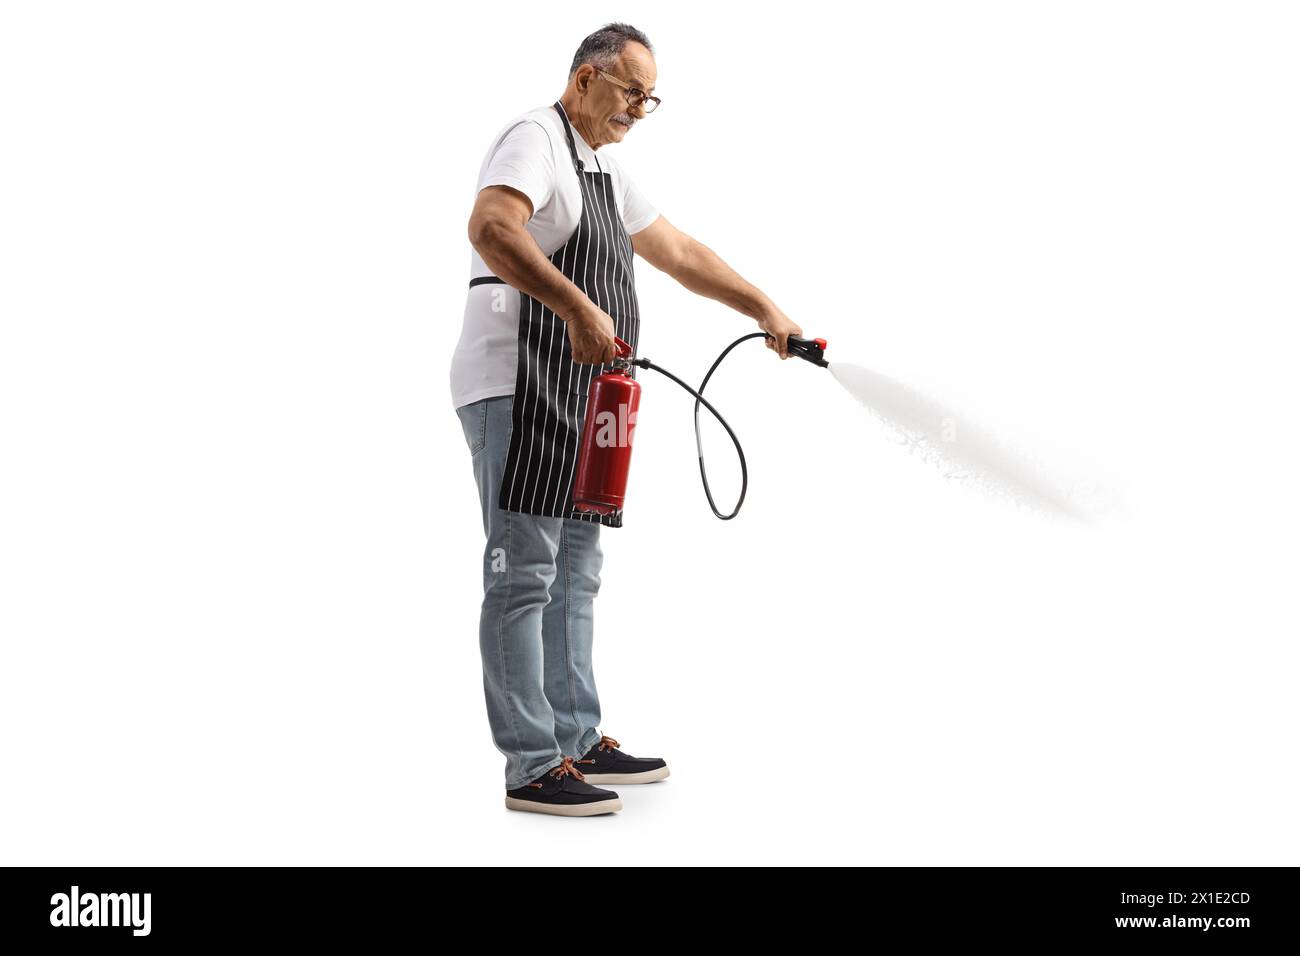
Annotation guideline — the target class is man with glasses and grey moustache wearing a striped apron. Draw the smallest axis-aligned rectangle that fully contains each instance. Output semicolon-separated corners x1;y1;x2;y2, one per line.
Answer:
451;23;802;817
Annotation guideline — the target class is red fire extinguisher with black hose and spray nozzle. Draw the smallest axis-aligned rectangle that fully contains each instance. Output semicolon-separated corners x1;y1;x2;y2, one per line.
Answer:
573;332;829;520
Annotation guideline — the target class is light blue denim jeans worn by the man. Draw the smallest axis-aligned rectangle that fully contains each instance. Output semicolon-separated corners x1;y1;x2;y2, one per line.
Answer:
456;395;603;790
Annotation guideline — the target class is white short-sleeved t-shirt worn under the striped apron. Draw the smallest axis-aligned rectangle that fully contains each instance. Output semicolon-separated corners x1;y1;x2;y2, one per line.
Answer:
451;107;659;408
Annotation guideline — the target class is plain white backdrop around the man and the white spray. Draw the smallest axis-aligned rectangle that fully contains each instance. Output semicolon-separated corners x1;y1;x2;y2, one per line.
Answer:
0;0;1300;865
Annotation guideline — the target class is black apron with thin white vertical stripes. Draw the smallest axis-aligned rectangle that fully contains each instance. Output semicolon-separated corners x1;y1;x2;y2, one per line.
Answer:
471;103;641;528
